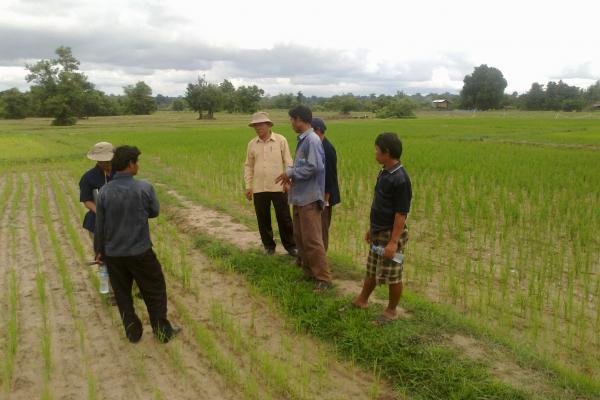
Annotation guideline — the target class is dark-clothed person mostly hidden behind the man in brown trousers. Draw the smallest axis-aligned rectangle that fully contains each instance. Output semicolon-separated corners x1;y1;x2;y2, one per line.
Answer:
310;117;340;251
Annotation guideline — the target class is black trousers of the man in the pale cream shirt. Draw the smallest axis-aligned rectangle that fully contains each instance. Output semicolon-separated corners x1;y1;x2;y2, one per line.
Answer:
253;192;296;251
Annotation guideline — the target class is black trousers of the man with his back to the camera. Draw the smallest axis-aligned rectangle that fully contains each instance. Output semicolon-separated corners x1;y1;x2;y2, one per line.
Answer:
105;249;173;342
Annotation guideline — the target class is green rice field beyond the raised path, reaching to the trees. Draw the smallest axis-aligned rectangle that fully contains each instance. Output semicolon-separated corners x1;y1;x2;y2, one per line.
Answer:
0;112;600;396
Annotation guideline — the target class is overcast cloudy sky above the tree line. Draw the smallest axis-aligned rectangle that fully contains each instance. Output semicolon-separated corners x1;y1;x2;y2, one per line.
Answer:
0;0;600;96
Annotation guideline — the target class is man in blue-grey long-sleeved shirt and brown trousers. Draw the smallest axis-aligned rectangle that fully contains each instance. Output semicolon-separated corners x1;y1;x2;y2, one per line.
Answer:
275;105;332;293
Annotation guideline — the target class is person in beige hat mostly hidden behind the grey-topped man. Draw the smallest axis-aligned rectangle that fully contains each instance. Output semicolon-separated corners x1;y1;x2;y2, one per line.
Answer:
79;142;117;306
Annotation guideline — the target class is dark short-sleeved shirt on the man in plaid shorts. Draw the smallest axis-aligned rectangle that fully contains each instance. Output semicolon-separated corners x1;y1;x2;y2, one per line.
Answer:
371;163;412;233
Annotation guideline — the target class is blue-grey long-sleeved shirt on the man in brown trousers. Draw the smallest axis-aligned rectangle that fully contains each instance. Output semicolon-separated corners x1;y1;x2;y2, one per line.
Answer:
286;128;325;206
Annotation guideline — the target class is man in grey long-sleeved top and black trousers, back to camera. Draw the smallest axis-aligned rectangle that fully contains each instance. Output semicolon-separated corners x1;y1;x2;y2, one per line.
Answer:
94;146;181;343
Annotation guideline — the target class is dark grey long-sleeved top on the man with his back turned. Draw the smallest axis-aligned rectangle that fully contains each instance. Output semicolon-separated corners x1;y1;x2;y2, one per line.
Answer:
94;172;160;257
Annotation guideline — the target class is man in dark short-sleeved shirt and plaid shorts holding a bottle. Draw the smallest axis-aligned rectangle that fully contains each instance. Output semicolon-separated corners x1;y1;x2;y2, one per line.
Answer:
352;133;412;325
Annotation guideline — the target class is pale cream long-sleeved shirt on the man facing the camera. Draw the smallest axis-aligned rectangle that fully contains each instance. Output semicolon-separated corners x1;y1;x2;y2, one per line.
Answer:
244;132;293;193
